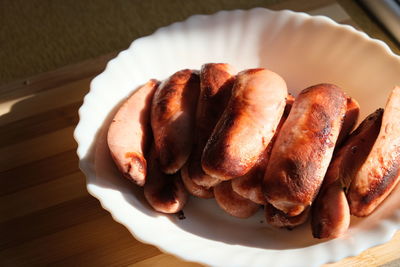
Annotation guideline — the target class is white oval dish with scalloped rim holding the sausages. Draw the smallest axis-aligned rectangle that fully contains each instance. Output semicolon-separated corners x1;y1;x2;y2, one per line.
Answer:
75;8;400;266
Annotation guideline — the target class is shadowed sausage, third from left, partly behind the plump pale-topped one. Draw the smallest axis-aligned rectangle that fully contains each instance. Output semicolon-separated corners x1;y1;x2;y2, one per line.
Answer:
188;63;234;188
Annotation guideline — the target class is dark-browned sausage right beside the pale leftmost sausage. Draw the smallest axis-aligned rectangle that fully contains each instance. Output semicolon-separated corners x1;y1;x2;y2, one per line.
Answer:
151;69;200;174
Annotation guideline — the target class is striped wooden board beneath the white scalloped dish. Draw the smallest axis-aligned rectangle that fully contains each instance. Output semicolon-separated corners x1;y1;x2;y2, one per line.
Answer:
0;0;400;266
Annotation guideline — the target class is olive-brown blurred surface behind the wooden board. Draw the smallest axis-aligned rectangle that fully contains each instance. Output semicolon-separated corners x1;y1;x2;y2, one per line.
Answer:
0;0;395;84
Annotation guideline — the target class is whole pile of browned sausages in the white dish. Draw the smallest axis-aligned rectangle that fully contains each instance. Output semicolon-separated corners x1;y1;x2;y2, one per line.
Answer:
107;63;400;238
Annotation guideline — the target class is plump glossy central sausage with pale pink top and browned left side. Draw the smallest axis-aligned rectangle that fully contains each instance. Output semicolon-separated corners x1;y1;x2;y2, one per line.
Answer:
202;69;287;180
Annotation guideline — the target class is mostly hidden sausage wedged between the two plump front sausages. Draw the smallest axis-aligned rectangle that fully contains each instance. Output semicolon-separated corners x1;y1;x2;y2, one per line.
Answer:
232;95;294;205
